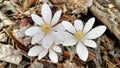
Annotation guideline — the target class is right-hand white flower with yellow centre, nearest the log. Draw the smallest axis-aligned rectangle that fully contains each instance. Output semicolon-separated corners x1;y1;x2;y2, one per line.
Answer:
62;18;106;61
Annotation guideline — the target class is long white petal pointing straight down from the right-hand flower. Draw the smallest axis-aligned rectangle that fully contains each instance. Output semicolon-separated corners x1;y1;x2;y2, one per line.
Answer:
76;42;88;61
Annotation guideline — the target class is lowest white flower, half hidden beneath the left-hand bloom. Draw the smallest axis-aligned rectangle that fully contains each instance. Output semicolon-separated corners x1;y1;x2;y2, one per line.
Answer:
28;44;61;63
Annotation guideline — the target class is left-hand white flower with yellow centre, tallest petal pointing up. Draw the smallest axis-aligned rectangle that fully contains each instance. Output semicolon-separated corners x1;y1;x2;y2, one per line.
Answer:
25;3;62;49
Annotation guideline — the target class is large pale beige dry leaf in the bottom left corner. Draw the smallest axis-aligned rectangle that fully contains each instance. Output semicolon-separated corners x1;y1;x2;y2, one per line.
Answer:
0;44;22;65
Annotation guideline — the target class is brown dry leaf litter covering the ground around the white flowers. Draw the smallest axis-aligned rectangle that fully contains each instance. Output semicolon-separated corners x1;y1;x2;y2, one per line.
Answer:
0;0;120;68
